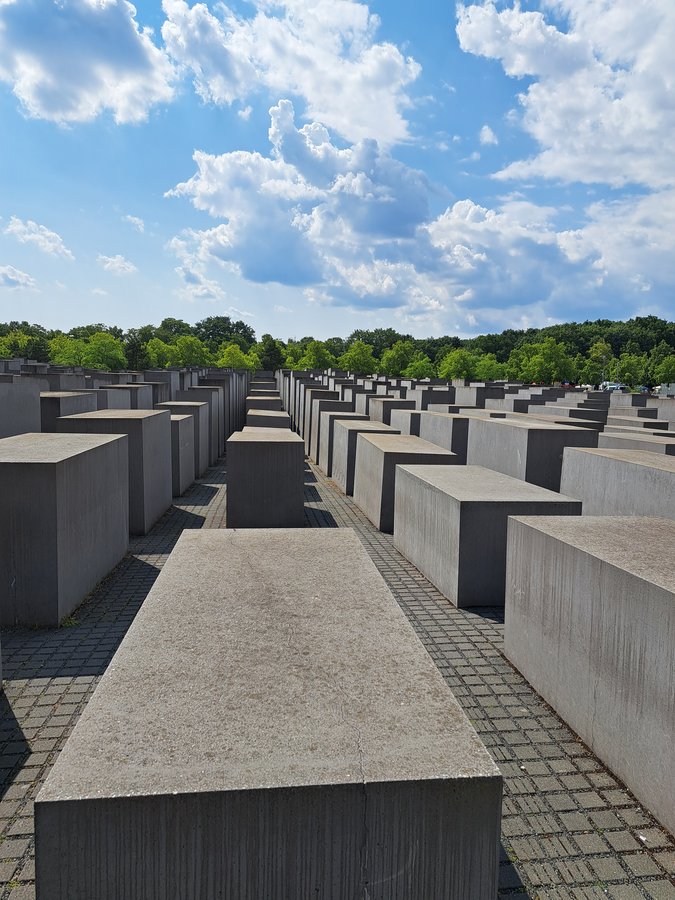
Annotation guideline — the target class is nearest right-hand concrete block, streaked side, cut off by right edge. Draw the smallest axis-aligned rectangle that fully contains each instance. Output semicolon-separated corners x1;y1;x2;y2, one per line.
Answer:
505;516;675;833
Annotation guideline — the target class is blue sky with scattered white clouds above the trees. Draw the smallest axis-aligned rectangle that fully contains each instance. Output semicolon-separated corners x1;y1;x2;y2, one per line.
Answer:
0;0;675;340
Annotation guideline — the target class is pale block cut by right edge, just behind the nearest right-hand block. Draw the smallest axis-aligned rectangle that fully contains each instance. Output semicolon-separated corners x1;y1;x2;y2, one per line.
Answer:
560;447;675;519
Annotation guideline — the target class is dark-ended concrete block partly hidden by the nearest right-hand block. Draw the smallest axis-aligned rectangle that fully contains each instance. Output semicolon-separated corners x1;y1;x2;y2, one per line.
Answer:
394;465;581;607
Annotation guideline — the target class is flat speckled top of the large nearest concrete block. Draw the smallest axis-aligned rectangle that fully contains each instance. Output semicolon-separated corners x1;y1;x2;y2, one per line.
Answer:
37;529;500;804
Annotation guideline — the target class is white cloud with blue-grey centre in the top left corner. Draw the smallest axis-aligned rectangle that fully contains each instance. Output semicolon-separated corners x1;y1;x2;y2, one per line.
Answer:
0;0;173;123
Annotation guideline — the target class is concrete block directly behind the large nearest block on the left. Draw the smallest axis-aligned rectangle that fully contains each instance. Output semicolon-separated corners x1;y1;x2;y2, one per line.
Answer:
58;409;173;534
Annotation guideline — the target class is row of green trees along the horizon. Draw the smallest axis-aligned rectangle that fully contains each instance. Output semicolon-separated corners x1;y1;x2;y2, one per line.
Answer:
0;316;675;387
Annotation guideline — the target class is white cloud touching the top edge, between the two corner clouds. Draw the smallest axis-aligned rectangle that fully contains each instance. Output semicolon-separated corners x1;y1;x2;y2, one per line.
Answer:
162;0;420;144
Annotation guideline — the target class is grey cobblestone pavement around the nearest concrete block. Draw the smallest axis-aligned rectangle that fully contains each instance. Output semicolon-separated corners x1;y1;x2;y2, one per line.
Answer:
0;461;675;900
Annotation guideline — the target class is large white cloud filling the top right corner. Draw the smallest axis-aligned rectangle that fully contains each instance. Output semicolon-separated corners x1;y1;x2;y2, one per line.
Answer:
457;0;675;189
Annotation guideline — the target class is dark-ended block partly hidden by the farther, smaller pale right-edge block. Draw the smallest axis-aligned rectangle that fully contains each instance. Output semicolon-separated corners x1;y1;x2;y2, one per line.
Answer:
466;416;598;488
